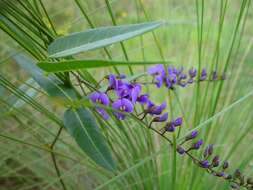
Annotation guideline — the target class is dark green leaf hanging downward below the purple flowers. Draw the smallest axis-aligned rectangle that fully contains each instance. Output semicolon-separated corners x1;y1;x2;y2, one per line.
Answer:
64;108;116;171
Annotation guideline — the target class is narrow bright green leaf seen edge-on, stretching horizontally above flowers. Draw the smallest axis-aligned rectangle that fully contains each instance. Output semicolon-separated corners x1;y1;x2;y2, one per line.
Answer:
37;60;170;73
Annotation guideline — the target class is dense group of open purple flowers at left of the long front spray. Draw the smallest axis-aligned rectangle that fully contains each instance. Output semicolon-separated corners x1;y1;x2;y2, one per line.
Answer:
89;74;168;122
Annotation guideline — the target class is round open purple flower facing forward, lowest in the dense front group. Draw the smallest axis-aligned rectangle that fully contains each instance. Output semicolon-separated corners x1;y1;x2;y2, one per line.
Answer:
112;98;134;120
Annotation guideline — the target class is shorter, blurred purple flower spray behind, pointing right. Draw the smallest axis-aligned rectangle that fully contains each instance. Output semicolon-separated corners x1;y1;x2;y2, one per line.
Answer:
148;64;225;89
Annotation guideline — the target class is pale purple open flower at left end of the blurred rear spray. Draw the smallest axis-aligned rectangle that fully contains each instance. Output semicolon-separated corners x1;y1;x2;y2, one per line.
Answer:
148;64;166;88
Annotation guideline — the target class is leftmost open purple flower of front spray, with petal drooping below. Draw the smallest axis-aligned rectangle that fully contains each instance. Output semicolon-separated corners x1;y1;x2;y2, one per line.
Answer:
89;92;110;120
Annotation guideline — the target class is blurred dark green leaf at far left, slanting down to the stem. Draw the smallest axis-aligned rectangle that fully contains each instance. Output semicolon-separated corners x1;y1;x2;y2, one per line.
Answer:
14;54;76;98
